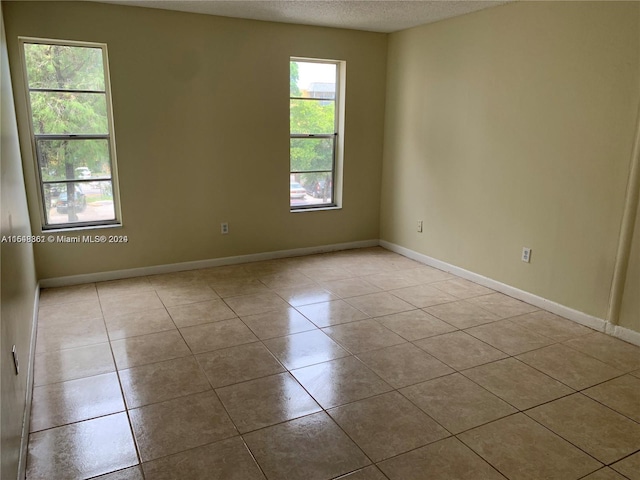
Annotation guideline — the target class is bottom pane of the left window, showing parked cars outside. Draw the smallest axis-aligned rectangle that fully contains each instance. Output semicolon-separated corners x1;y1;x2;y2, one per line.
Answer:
44;181;116;225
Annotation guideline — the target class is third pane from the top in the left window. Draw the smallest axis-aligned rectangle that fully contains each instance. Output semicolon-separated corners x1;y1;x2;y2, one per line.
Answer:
38;139;111;182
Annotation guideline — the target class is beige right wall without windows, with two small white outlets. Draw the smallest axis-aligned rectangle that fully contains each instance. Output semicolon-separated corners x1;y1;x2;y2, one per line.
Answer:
380;2;640;318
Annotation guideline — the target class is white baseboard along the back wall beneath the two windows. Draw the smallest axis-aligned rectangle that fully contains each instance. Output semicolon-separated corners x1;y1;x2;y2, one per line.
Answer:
40;239;380;288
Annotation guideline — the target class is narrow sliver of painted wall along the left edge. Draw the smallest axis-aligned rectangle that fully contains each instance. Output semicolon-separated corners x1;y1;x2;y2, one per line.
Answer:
0;4;37;480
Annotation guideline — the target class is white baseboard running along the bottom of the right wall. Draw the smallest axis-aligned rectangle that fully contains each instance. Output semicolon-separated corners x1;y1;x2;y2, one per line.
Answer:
380;240;640;346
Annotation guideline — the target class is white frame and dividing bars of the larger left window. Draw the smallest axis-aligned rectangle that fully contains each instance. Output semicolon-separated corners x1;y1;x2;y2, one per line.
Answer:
18;37;122;231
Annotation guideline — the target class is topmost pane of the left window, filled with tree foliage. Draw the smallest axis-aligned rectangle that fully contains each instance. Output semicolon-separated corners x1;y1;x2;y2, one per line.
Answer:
24;43;104;91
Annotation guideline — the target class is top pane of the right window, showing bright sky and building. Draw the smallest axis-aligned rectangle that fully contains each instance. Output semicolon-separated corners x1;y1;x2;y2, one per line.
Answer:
289;61;336;98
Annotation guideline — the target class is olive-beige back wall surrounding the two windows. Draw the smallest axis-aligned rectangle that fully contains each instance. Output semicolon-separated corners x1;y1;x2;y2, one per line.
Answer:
3;2;387;278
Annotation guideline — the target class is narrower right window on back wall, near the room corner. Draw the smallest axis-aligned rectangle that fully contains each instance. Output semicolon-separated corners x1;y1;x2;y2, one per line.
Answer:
289;58;344;210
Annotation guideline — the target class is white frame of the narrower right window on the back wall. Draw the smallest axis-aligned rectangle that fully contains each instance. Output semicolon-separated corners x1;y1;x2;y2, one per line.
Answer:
289;56;347;213
